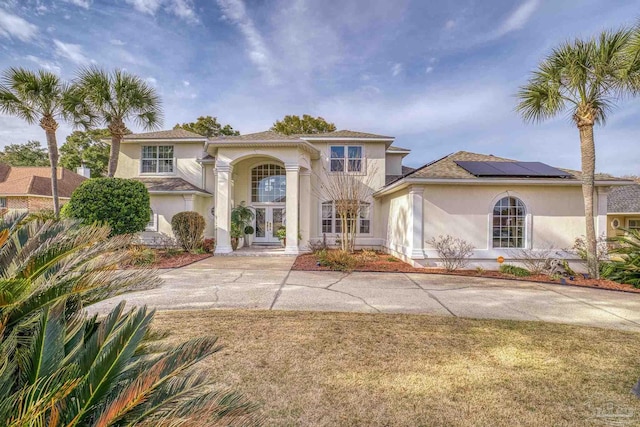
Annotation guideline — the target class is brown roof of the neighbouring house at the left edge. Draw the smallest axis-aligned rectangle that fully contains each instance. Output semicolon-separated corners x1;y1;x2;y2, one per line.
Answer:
0;163;87;198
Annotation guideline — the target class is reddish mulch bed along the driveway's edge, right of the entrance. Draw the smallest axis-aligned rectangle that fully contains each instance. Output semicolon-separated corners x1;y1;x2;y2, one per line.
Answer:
291;253;640;293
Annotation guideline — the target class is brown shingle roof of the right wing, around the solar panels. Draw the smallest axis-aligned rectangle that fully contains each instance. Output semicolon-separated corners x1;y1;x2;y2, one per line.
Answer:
406;151;618;180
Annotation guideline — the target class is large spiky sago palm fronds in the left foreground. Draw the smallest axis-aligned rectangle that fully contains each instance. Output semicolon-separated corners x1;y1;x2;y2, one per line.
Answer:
0;215;252;427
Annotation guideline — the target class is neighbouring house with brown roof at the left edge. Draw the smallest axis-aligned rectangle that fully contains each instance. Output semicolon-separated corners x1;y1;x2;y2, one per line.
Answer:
0;163;87;212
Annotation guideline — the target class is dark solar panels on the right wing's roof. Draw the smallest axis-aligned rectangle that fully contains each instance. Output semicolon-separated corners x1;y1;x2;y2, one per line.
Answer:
456;161;572;178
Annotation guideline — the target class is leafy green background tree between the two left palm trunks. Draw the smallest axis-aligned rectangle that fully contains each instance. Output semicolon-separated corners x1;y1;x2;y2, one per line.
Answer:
60;128;117;178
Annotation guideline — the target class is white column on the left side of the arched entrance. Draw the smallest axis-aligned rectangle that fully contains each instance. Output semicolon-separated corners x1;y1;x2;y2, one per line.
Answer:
215;163;233;254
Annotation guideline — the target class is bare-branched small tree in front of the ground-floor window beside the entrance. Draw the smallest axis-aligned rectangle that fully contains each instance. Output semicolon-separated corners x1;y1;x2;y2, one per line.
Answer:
316;158;377;252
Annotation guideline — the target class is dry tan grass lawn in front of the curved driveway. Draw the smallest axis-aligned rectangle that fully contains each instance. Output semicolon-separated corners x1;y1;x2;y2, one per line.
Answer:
155;311;640;426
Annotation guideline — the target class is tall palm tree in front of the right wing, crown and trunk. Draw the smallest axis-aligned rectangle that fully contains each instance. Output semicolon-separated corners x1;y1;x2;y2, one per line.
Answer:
517;29;637;277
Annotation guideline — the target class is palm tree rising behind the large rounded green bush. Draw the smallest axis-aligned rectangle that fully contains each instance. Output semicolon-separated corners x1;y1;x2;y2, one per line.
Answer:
68;67;162;177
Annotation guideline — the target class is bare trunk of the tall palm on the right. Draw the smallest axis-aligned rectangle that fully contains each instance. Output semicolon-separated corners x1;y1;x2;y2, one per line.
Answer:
578;120;600;278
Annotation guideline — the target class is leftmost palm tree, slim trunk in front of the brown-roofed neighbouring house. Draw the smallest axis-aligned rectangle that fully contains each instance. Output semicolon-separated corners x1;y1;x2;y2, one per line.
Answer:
0;68;67;216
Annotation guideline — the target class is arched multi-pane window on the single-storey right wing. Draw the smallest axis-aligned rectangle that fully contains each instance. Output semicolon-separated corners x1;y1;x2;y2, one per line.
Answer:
492;197;527;248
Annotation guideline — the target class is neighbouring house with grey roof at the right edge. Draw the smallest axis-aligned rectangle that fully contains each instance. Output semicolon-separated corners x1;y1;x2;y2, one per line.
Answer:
607;184;640;237
